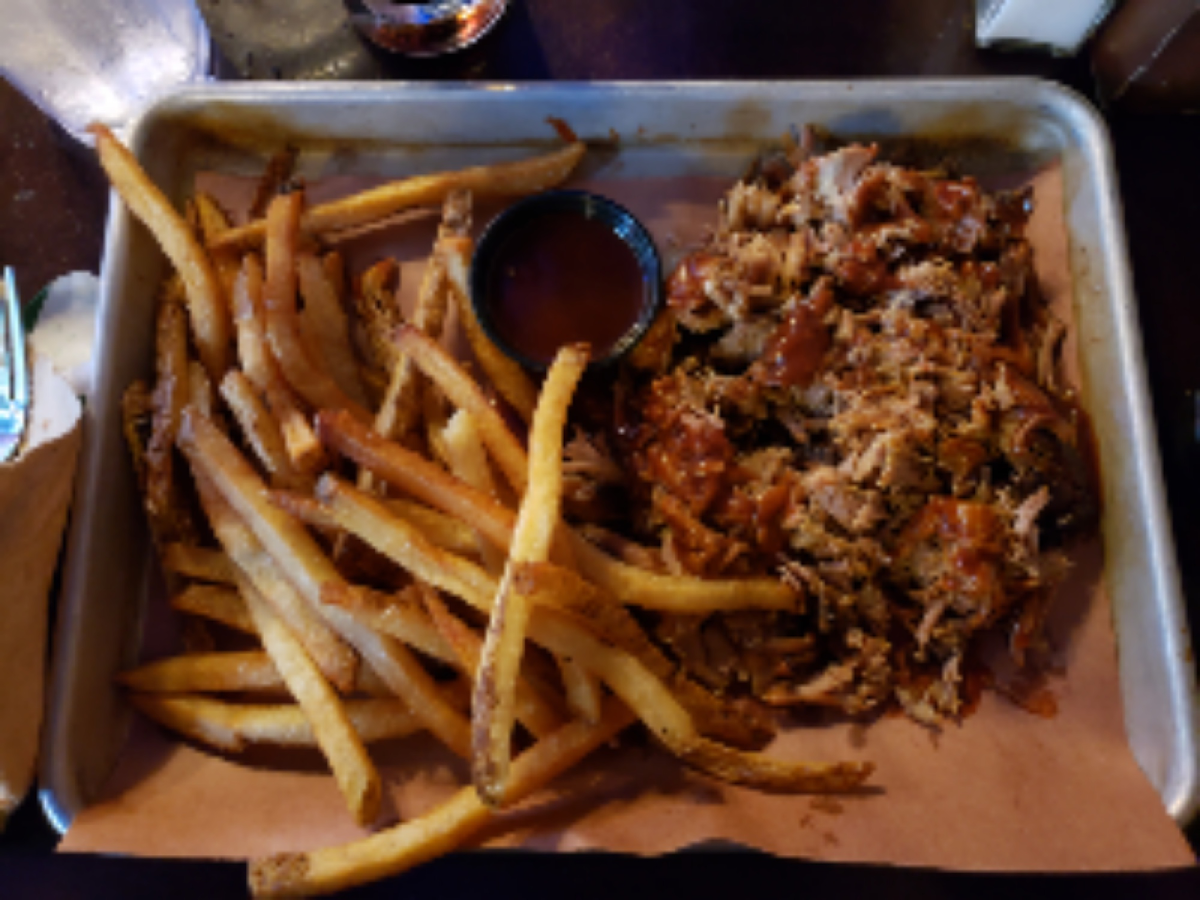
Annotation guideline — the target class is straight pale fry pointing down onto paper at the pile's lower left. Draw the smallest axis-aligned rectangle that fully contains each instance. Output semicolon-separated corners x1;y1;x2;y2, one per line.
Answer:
234;573;383;826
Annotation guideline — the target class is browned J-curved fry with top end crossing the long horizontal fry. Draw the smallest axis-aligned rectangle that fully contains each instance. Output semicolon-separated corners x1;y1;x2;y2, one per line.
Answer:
263;191;371;421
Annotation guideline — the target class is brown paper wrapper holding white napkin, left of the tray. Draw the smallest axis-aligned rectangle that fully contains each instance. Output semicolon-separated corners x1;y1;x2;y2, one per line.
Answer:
0;358;83;827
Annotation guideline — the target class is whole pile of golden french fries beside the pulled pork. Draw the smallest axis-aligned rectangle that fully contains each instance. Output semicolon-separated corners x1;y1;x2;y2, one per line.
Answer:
92;121;871;896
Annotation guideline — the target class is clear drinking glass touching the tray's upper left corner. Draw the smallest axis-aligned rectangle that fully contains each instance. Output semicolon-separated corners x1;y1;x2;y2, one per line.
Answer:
0;0;209;142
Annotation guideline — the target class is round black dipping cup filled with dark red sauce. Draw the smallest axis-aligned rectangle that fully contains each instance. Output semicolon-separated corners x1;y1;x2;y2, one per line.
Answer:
470;191;662;371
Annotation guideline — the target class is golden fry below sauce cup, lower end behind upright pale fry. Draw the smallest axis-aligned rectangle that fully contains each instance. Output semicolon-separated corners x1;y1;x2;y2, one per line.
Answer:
396;325;528;497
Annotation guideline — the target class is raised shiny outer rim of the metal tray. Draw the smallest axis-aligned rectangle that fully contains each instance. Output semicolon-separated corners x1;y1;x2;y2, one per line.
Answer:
40;77;1200;833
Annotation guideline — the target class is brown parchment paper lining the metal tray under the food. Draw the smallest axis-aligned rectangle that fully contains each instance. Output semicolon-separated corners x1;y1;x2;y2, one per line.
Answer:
61;164;1193;870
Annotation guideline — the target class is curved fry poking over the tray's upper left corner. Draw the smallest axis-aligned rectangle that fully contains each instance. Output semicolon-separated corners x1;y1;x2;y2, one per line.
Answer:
89;124;232;380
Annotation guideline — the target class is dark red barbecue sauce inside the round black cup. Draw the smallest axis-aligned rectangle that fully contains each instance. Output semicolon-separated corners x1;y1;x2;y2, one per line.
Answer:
487;211;647;364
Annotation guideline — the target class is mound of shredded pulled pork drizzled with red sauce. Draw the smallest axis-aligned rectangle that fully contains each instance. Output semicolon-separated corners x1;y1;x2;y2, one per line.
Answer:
590;139;1096;721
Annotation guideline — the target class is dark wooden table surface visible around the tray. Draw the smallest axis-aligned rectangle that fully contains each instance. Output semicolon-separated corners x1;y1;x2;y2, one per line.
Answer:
0;0;1200;899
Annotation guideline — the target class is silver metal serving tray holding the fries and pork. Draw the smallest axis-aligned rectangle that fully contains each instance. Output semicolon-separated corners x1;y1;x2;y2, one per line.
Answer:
41;79;1200;830
